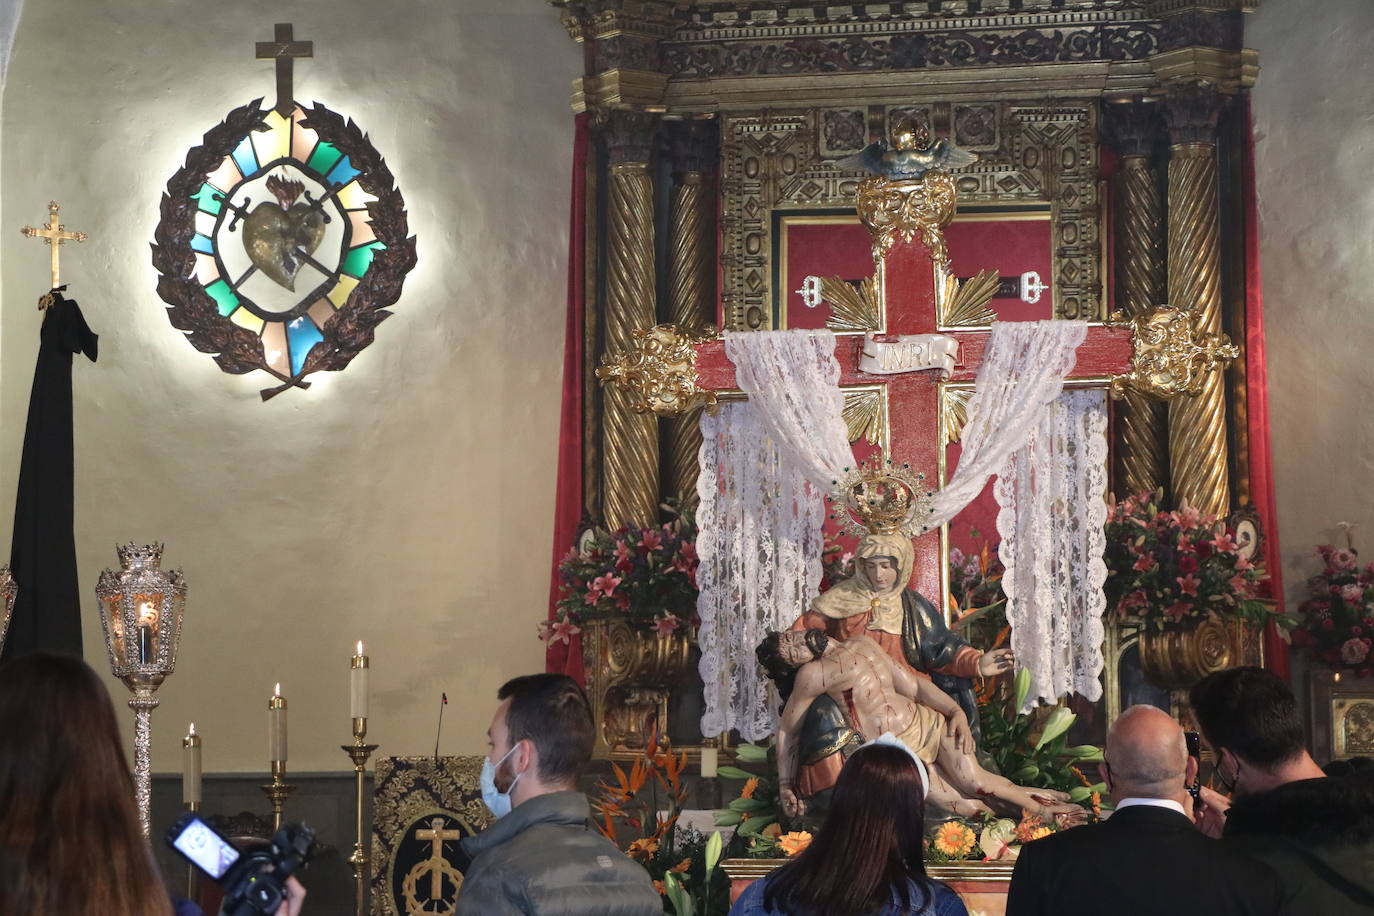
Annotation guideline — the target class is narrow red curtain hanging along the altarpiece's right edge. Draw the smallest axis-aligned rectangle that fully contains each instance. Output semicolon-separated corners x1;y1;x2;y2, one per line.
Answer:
1241;98;1290;680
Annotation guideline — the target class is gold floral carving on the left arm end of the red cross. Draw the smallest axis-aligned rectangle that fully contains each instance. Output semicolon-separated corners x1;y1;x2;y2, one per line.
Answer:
596;324;719;416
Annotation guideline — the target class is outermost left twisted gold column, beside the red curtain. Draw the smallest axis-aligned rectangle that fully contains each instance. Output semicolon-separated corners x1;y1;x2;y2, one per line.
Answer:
602;111;658;527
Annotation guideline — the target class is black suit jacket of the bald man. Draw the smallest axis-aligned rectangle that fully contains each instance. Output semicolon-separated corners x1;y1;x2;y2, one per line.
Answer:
1007;805;1282;916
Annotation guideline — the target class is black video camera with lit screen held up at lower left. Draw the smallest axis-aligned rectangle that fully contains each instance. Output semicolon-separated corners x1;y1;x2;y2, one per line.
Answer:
168;812;315;916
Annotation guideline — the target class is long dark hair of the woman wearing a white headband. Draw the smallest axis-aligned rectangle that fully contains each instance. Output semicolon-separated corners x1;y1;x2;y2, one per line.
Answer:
764;744;932;916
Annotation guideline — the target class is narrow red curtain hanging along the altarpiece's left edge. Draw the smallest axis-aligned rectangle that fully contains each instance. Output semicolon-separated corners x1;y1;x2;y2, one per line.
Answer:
544;113;588;684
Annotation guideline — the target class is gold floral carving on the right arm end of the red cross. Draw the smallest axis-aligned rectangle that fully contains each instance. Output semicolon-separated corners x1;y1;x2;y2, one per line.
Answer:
1112;305;1238;401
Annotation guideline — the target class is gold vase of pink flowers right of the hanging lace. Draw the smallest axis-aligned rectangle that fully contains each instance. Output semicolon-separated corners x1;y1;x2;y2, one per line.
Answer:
1103;493;1276;689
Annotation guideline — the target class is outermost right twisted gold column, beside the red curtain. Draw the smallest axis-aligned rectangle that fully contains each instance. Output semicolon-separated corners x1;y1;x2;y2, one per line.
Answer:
1164;85;1231;515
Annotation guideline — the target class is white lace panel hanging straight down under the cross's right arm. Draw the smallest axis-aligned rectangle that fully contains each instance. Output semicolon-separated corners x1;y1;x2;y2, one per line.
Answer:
993;390;1107;711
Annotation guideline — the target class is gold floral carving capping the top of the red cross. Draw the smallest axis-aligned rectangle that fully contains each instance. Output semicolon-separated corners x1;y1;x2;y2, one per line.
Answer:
855;170;959;271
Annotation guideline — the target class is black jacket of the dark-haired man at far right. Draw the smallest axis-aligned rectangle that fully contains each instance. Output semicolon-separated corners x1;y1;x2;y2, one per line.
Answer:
1223;773;1374;916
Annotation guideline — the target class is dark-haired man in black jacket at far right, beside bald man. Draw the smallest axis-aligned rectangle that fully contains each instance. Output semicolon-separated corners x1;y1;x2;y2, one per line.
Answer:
1189;667;1374;916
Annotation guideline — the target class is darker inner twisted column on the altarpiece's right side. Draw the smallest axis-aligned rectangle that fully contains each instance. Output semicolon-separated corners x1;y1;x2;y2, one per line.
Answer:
1105;100;1168;496
